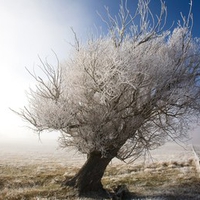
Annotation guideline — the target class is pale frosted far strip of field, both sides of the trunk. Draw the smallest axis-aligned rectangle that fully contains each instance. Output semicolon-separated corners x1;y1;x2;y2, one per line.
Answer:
0;139;197;166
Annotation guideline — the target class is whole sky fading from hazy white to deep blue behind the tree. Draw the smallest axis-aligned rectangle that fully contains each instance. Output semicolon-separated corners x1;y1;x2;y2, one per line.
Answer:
0;0;200;145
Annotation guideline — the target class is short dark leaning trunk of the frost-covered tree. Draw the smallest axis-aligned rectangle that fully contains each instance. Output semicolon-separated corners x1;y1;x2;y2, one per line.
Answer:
63;152;114;195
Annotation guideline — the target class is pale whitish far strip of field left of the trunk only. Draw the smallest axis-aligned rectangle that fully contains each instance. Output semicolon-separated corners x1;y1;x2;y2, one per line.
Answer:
0;140;84;165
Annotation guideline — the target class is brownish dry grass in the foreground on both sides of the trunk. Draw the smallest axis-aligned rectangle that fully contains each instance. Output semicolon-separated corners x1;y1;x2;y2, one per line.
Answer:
0;160;200;200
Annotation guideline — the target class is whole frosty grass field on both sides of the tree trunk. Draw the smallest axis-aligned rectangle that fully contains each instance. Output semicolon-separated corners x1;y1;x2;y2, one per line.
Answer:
0;140;200;200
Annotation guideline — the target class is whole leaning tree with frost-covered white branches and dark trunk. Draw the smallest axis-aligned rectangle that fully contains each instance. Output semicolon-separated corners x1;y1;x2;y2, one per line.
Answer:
14;0;200;197
